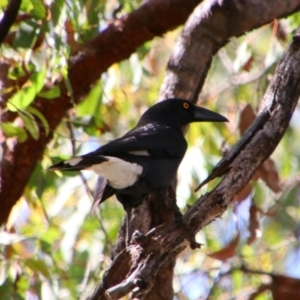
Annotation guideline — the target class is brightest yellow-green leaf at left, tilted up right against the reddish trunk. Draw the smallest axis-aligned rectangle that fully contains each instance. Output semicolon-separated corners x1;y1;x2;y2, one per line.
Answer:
7;68;46;111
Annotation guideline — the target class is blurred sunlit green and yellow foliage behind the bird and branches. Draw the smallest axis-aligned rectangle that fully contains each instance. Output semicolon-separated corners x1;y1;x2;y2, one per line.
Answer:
0;0;300;299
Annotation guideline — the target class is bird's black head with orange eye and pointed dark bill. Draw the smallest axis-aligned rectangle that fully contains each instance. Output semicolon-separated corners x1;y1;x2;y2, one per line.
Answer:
138;99;228;128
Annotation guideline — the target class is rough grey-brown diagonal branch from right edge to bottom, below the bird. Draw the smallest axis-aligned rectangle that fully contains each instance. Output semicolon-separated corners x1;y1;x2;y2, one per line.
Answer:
90;30;300;299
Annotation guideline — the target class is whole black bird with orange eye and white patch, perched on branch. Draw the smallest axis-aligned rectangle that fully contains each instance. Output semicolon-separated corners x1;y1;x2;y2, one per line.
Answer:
49;99;227;209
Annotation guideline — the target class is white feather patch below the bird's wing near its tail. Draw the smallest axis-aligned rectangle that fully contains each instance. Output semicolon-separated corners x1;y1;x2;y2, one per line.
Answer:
87;156;143;189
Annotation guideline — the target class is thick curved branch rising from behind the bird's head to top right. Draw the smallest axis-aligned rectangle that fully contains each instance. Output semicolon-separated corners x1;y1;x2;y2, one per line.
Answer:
160;0;300;103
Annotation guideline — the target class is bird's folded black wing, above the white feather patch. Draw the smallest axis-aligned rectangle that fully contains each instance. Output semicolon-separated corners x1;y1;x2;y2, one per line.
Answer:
90;124;187;158
